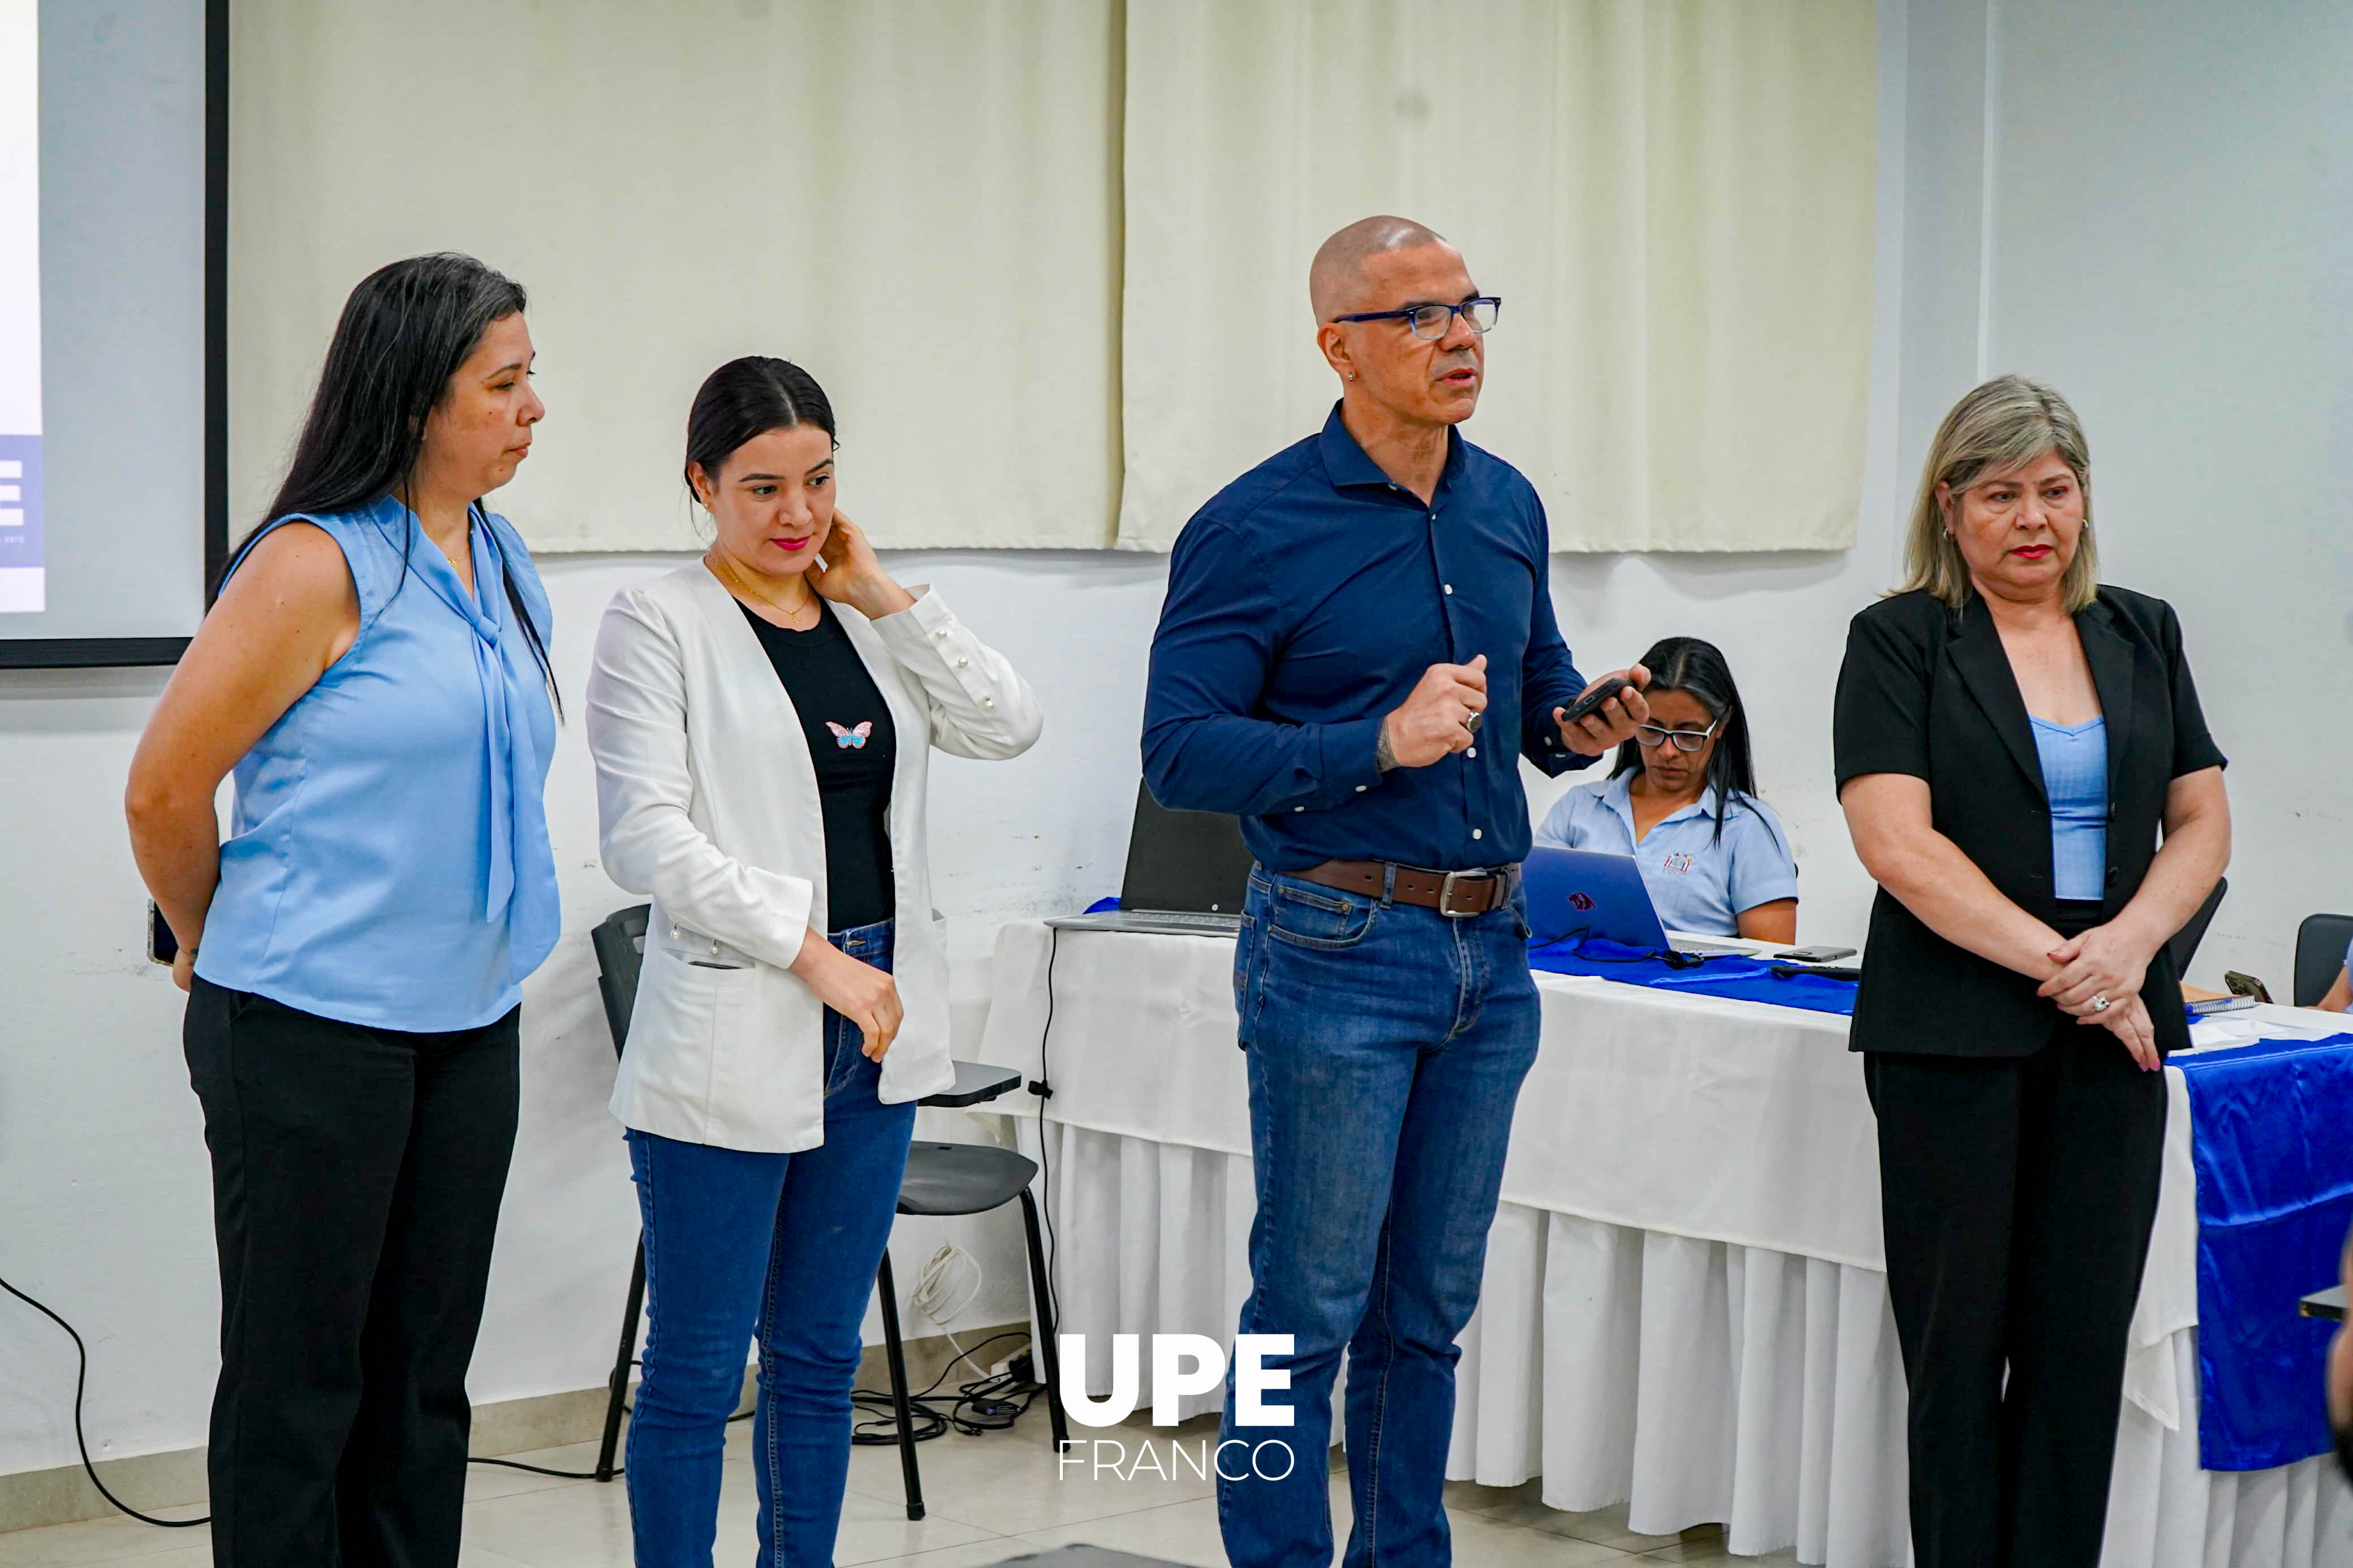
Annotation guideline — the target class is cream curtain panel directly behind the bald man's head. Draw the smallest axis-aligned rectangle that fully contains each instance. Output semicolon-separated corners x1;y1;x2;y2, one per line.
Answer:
1120;0;1878;550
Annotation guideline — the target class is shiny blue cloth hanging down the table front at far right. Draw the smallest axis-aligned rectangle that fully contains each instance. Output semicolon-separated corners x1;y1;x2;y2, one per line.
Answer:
2172;1034;2353;1469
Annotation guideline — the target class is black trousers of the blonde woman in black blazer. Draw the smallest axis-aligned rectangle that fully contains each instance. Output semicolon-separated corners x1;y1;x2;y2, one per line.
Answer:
1864;1016;2165;1568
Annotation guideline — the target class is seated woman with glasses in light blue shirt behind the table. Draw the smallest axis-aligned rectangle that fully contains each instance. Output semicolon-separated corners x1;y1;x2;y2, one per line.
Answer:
1536;637;1798;943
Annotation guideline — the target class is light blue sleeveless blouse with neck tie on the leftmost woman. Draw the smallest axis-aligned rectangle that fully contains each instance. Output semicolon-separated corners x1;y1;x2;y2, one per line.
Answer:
195;498;560;1032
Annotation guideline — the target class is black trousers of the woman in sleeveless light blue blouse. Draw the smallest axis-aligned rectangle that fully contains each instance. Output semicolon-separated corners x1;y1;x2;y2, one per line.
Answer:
183;980;518;1568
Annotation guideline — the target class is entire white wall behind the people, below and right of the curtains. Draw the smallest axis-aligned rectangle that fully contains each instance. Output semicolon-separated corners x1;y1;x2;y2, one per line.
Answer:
0;0;2353;1474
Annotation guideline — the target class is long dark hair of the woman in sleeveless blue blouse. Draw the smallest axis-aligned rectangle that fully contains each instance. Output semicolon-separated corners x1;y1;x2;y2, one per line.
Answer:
221;252;562;712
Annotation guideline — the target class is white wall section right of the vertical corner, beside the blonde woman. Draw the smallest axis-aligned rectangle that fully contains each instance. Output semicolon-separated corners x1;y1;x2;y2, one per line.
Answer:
1986;0;2353;1001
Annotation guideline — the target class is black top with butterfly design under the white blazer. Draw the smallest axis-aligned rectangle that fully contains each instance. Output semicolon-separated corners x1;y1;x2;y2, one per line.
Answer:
739;599;899;931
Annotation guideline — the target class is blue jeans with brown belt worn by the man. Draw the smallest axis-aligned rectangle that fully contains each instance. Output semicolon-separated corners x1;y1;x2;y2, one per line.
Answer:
1217;867;1536;1568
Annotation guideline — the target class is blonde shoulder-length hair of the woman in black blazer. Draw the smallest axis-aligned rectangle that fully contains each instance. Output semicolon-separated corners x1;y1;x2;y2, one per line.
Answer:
1897;376;2099;616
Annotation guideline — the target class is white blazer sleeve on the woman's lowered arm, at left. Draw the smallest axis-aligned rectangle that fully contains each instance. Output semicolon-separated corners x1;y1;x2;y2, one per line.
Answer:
588;588;814;969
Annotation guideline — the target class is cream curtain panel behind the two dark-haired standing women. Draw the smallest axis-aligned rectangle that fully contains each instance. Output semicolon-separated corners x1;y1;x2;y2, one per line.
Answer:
229;0;1120;550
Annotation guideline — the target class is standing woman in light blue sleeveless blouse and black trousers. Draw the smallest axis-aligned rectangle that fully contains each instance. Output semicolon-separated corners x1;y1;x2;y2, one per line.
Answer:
127;256;560;1568
